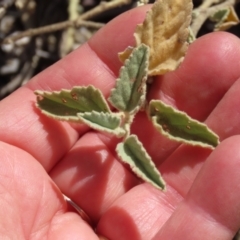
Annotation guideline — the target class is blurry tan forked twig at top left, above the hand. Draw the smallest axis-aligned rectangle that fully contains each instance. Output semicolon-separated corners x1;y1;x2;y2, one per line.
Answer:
3;0;131;44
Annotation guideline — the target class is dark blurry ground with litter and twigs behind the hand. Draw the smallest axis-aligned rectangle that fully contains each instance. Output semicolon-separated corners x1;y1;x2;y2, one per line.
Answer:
0;0;240;100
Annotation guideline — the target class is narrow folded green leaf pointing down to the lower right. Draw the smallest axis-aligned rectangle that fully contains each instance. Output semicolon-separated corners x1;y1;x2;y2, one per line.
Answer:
116;135;165;190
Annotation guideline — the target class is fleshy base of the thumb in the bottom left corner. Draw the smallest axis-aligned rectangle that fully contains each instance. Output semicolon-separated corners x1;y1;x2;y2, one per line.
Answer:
0;142;98;240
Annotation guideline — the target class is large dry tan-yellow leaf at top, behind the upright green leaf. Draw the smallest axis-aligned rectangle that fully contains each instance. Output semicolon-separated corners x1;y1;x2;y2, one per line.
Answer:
119;0;192;75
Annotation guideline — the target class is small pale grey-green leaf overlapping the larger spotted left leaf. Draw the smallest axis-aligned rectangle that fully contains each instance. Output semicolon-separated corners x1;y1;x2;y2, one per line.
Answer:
77;111;125;137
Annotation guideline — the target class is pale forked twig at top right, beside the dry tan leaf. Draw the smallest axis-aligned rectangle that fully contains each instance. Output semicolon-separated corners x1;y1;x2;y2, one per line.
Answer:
191;0;236;36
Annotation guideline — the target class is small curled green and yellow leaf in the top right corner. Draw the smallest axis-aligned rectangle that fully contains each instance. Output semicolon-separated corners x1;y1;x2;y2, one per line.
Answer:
210;6;239;31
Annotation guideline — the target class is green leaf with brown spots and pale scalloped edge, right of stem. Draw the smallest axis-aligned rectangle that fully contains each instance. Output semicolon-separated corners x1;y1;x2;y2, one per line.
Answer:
149;100;219;149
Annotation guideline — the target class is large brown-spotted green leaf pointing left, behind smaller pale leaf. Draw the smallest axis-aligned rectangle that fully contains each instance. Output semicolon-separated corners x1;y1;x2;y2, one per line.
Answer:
35;86;110;121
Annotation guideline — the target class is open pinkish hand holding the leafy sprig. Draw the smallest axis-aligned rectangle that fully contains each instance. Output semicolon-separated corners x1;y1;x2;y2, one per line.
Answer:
0;7;240;240
